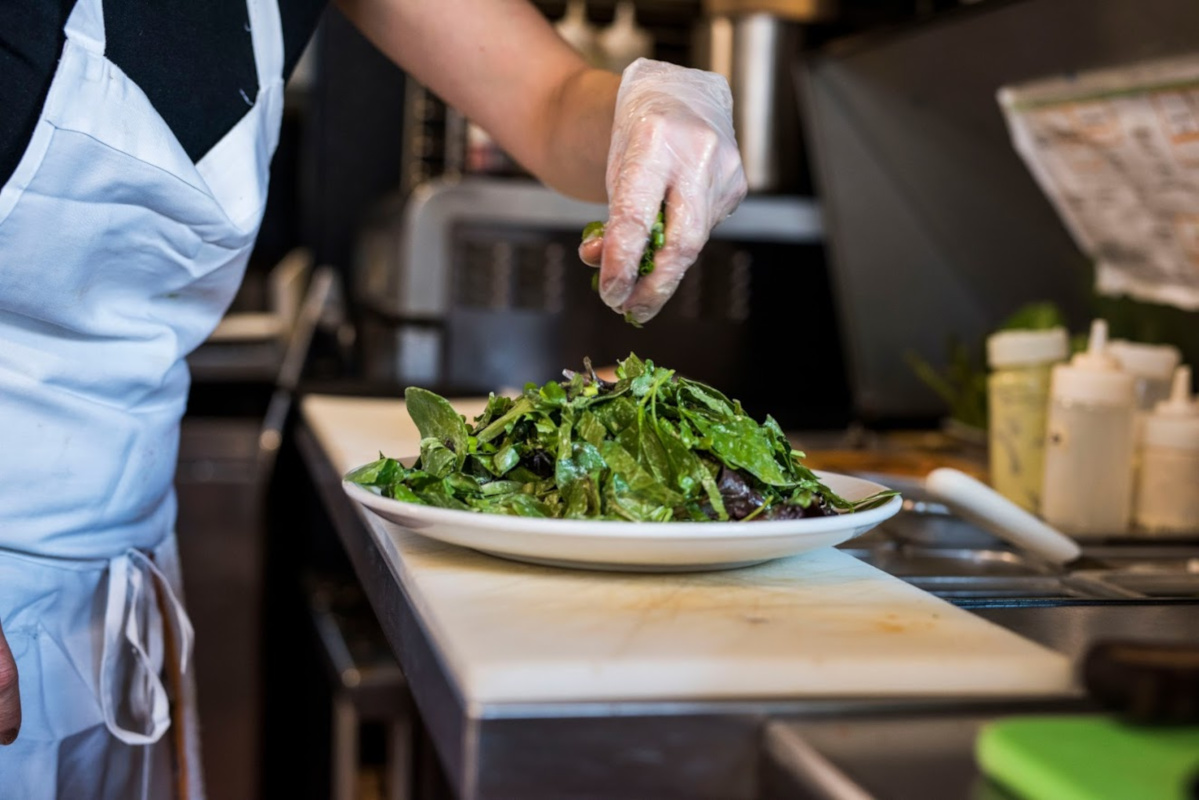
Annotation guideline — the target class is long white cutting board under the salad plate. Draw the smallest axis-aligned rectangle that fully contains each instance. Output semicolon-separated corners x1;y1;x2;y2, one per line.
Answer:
303;396;1073;708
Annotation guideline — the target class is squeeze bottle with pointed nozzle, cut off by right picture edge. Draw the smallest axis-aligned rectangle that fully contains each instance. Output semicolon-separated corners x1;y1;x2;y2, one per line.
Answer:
1134;367;1199;536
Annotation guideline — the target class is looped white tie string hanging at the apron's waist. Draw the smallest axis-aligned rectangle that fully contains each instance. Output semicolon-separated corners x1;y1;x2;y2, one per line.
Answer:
100;548;194;745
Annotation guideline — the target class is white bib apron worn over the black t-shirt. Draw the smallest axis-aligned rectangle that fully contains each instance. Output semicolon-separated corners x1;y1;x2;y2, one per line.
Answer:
0;0;283;800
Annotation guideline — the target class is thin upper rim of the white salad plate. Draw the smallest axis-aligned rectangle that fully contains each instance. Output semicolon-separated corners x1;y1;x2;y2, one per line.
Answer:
342;470;903;540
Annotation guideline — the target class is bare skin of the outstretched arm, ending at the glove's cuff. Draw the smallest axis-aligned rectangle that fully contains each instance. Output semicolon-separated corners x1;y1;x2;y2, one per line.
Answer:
338;0;620;201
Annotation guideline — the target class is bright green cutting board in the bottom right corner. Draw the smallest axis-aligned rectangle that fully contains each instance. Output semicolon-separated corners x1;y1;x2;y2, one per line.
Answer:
976;716;1199;800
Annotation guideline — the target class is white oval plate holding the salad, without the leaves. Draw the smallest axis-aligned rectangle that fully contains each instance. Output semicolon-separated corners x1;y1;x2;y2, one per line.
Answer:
342;473;902;572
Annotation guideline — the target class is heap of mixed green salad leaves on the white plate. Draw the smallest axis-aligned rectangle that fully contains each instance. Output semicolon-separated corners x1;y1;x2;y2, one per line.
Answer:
347;355;893;522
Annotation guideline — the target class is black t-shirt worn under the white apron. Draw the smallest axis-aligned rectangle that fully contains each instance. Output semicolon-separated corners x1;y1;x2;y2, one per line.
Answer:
0;0;326;186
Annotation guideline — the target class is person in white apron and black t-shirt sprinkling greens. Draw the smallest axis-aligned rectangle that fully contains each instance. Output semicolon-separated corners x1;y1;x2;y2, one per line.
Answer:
0;0;746;800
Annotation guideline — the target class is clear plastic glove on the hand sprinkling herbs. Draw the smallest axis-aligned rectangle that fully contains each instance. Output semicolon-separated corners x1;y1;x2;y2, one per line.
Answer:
579;59;746;323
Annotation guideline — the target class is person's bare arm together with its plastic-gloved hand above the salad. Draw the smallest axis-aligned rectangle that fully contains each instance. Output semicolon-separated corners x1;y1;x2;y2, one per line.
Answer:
338;0;746;324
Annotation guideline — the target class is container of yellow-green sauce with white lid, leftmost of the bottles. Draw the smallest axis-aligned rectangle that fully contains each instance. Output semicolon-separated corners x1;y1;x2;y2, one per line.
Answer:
987;327;1070;513
